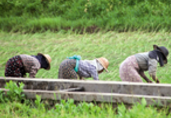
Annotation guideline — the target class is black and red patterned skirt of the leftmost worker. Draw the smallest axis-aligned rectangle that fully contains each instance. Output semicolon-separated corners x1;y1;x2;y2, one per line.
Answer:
5;56;26;77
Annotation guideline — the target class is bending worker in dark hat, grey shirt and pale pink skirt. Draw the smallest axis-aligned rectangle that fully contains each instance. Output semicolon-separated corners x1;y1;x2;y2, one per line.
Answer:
119;45;169;83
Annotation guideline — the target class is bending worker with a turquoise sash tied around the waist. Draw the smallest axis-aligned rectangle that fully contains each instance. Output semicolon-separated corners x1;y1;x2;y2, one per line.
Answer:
58;55;109;80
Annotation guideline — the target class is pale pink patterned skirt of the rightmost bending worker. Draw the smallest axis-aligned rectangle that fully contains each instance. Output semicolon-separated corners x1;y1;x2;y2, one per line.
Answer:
119;56;143;82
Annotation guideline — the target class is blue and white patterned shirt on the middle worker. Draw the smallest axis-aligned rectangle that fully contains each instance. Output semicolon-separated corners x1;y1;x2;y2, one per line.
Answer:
77;60;99;80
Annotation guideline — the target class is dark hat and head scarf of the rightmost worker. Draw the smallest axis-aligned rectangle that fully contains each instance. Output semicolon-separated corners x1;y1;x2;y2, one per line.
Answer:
149;45;169;66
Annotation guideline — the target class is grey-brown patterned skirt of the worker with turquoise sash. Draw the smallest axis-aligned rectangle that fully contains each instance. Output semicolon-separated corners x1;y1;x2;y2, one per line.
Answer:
58;59;78;79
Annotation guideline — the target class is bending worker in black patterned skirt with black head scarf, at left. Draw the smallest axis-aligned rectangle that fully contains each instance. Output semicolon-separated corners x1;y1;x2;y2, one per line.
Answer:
5;53;51;78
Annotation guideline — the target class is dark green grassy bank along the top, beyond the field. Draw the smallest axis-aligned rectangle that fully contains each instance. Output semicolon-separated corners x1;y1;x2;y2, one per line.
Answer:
0;0;171;33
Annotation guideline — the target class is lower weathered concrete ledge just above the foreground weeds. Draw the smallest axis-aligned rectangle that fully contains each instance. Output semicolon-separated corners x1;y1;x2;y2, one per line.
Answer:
0;88;171;107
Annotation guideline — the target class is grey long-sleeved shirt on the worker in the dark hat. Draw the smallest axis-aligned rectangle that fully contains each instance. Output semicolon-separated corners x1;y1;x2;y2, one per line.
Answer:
135;52;158;75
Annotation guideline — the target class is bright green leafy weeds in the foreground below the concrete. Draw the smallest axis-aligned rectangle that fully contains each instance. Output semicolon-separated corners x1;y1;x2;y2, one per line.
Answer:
0;81;171;118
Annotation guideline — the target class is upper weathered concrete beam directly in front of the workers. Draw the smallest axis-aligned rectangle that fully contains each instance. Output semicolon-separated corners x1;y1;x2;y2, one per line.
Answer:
0;77;171;96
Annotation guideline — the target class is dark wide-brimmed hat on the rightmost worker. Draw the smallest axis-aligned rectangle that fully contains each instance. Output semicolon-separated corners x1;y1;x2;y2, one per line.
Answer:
153;45;169;64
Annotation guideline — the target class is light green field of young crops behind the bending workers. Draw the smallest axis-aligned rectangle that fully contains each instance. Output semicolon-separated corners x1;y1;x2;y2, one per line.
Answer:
0;31;171;83
